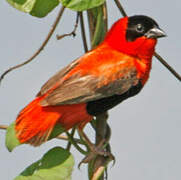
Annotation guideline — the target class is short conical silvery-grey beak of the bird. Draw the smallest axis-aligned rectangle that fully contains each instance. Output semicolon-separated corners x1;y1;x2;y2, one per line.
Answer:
145;27;167;38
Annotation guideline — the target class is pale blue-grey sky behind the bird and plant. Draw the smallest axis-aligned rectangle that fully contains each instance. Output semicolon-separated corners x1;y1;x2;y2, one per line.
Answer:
0;0;181;180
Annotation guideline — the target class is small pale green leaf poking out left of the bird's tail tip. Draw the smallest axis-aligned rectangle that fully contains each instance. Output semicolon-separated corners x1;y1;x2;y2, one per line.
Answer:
5;122;21;152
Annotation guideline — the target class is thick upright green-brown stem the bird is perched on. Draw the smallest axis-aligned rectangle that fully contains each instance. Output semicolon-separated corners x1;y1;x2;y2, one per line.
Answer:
87;3;109;180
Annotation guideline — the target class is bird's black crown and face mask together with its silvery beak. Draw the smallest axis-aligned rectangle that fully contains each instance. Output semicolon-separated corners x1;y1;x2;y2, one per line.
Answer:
126;15;166;41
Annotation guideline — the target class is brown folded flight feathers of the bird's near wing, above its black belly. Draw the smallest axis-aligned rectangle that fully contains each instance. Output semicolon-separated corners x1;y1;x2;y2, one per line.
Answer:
41;69;138;106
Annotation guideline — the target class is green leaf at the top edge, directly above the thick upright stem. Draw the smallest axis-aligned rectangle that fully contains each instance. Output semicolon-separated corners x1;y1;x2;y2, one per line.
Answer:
60;0;105;11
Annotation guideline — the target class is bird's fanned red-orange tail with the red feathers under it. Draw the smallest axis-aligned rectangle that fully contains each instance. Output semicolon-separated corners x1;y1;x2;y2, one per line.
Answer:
15;97;92;146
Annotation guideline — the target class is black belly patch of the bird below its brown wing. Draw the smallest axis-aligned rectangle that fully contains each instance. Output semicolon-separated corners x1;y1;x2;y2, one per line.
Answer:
87;82;143;116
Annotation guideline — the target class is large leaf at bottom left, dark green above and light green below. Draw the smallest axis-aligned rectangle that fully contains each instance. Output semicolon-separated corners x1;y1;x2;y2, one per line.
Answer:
15;147;74;180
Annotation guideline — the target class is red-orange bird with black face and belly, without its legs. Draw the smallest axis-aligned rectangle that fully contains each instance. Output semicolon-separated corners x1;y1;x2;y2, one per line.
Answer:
15;15;165;146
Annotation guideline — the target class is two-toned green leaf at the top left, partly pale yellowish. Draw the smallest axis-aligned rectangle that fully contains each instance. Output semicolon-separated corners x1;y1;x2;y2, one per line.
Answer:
7;0;59;17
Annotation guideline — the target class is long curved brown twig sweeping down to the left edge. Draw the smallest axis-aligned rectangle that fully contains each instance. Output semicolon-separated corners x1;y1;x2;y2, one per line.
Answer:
0;6;65;83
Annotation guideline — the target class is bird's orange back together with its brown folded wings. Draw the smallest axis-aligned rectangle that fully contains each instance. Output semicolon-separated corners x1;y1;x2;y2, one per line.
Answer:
38;45;138;106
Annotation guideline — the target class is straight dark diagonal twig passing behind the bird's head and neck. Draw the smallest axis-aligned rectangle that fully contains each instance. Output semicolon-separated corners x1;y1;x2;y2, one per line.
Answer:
114;0;181;81
